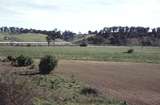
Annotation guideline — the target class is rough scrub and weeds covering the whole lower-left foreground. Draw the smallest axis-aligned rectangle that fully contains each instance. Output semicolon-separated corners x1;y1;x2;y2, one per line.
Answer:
0;65;126;105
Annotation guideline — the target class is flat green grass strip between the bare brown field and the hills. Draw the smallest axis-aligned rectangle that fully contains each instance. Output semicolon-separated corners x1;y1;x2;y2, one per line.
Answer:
0;46;160;63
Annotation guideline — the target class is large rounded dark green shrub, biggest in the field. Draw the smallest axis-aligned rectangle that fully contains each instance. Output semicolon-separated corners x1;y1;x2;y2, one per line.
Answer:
39;55;58;74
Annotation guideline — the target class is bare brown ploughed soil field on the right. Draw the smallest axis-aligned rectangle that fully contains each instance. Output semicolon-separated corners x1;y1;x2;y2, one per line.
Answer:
57;61;160;105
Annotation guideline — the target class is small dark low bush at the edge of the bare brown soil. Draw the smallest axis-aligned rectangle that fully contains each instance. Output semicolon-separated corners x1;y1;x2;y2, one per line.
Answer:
81;87;98;96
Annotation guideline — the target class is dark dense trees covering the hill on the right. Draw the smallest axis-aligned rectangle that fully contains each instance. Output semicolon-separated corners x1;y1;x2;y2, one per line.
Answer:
87;26;160;46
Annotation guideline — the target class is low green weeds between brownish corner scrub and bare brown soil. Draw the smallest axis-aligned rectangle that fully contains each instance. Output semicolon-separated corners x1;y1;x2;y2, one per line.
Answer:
32;75;126;105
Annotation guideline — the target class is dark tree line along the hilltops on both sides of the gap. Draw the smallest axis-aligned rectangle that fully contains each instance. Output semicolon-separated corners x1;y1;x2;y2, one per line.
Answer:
0;26;160;46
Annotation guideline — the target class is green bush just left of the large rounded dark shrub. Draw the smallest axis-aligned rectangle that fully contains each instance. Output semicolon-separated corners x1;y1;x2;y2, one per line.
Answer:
16;55;33;66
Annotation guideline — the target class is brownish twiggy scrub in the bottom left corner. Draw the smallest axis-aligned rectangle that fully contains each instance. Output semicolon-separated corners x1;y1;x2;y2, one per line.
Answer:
0;73;34;105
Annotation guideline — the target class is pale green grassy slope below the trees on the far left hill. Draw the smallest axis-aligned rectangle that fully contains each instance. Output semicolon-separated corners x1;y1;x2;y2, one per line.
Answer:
0;33;46;42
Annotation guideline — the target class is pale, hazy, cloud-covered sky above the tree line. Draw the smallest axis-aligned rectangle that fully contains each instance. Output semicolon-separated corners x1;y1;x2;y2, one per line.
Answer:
0;0;160;32
